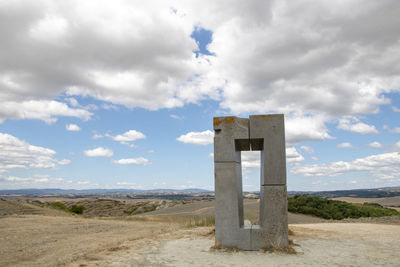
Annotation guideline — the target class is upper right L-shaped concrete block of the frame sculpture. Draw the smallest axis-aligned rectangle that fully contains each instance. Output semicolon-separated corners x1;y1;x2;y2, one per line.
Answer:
249;114;286;185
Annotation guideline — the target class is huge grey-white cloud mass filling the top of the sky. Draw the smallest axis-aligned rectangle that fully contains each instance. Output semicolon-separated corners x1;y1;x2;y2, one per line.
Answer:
0;0;400;143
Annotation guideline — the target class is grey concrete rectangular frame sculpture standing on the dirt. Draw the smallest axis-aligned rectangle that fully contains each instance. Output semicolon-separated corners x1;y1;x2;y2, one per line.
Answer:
214;114;288;250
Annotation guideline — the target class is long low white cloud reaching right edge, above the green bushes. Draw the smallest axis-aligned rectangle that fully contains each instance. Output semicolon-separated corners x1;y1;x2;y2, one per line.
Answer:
291;152;400;179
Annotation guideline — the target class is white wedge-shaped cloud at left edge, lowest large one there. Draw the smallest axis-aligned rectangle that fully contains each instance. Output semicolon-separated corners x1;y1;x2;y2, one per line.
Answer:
0;133;64;170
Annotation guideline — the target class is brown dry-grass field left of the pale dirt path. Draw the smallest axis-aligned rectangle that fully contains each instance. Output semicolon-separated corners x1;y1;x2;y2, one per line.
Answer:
0;215;179;266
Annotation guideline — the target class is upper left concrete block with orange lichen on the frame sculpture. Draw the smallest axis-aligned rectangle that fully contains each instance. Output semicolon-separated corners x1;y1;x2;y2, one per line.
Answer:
214;117;250;163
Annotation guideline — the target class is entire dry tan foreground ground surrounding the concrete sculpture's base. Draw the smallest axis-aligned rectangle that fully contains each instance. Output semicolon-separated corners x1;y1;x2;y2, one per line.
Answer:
0;215;400;267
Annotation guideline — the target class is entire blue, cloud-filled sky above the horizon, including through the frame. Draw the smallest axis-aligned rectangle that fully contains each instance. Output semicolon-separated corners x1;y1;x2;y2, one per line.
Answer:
0;0;400;191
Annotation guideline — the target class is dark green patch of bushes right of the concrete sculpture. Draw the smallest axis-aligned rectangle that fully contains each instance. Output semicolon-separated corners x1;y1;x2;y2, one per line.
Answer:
288;195;400;220
